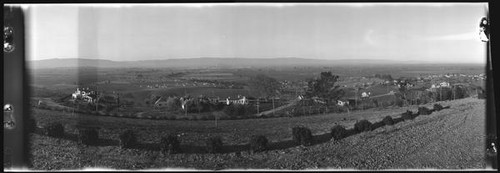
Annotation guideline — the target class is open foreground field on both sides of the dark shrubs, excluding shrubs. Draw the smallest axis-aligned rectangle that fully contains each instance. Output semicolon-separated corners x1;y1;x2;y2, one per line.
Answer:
31;98;485;170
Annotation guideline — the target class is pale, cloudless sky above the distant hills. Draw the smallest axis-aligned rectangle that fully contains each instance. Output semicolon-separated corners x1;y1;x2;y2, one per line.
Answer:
28;3;486;63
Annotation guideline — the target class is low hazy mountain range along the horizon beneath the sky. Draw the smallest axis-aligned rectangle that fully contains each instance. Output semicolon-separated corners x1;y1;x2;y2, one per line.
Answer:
29;58;474;69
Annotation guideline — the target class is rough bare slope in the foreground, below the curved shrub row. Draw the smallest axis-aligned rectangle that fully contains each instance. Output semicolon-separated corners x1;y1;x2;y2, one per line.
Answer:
31;98;485;170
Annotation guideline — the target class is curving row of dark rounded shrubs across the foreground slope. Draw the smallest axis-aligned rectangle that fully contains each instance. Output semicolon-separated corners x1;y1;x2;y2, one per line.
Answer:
39;104;449;154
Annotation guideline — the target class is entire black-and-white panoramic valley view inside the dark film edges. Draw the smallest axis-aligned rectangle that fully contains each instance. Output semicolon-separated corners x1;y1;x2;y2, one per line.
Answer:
9;3;494;170
